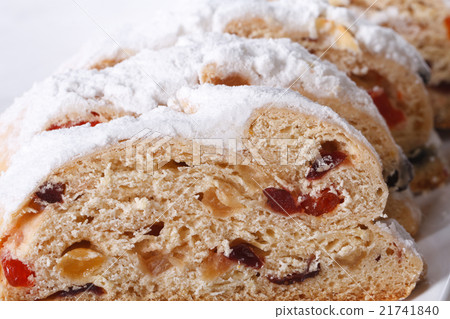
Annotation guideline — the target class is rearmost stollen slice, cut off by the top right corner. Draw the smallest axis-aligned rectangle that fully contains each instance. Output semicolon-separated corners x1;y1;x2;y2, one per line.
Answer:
330;0;450;129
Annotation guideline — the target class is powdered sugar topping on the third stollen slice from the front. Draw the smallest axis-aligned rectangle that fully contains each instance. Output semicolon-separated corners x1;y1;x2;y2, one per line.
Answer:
59;0;430;75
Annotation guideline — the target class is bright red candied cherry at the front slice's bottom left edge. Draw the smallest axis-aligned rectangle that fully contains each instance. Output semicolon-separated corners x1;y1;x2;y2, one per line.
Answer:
2;256;36;288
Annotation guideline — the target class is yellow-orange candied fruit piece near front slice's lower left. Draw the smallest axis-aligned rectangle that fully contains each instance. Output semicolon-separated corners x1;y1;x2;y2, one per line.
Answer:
57;248;106;280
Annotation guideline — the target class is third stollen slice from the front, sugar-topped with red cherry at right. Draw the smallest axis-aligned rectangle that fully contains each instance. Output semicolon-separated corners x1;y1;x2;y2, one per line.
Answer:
68;0;446;192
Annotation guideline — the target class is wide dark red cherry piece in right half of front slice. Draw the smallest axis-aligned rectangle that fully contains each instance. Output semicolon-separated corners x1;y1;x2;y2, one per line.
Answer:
264;187;344;216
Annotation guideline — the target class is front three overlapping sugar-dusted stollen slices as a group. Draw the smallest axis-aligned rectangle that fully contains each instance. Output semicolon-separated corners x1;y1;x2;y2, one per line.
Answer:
0;0;447;300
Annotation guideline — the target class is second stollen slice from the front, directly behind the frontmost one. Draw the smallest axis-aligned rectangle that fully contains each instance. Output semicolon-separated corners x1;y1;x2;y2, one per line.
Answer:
0;34;420;234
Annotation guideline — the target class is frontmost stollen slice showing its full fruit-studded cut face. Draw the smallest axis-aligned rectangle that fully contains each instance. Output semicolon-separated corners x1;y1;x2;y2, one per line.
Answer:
0;84;423;300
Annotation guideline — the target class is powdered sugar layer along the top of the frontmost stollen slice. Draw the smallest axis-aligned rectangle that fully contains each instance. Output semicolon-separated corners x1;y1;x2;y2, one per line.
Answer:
0;84;374;220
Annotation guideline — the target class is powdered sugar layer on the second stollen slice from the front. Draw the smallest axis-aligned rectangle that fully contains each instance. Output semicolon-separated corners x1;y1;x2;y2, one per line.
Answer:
2;34;388;170
